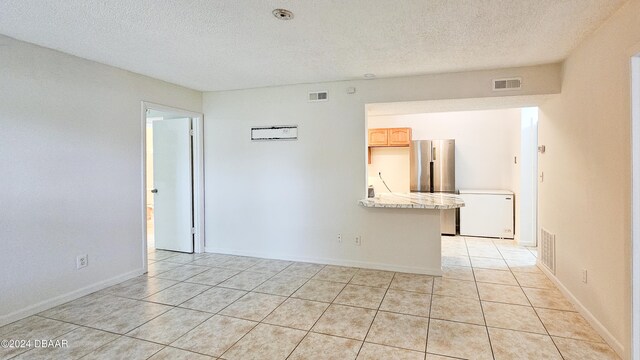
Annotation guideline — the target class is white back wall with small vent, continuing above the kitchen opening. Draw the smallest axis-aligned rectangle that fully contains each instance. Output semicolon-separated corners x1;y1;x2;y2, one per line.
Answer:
203;65;560;268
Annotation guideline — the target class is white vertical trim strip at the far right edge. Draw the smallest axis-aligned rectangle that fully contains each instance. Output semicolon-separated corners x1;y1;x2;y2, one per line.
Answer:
630;49;640;360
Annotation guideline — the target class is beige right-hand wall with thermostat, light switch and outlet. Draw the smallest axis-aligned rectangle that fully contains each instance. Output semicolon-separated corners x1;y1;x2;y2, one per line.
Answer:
539;0;640;358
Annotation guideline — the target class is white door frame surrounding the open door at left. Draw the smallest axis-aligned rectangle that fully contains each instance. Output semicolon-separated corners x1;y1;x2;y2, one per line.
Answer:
140;101;204;272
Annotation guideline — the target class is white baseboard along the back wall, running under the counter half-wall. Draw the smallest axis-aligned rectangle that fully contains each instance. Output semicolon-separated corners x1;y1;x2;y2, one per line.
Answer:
204;247;442;276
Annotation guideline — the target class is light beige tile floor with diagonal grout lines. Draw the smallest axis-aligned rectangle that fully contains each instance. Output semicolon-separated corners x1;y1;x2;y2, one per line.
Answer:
0;237;618;360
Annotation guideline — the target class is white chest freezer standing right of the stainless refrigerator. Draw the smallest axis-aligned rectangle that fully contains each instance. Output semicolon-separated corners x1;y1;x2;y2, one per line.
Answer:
460;190;514;239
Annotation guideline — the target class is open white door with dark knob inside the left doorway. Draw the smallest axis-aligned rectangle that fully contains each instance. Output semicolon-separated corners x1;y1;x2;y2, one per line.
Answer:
152;118;193;253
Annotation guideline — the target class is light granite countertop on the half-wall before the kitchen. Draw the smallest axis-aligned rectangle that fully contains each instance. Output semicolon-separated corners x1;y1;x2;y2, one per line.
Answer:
358;193;464;210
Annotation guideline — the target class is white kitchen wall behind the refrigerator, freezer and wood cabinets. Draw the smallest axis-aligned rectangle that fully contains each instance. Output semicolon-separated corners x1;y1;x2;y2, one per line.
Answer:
367;108;531;240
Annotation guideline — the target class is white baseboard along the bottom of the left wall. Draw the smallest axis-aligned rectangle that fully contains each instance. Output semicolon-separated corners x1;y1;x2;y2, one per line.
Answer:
0;268;145;326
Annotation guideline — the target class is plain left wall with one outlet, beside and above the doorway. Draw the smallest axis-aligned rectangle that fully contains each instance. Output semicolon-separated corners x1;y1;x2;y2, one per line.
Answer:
0;36;202;325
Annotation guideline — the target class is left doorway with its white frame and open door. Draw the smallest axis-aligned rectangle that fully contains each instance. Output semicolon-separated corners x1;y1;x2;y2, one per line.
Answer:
142;102;204;264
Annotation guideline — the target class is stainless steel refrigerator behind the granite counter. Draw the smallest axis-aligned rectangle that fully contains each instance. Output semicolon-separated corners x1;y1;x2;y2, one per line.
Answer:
409;139;456;235
